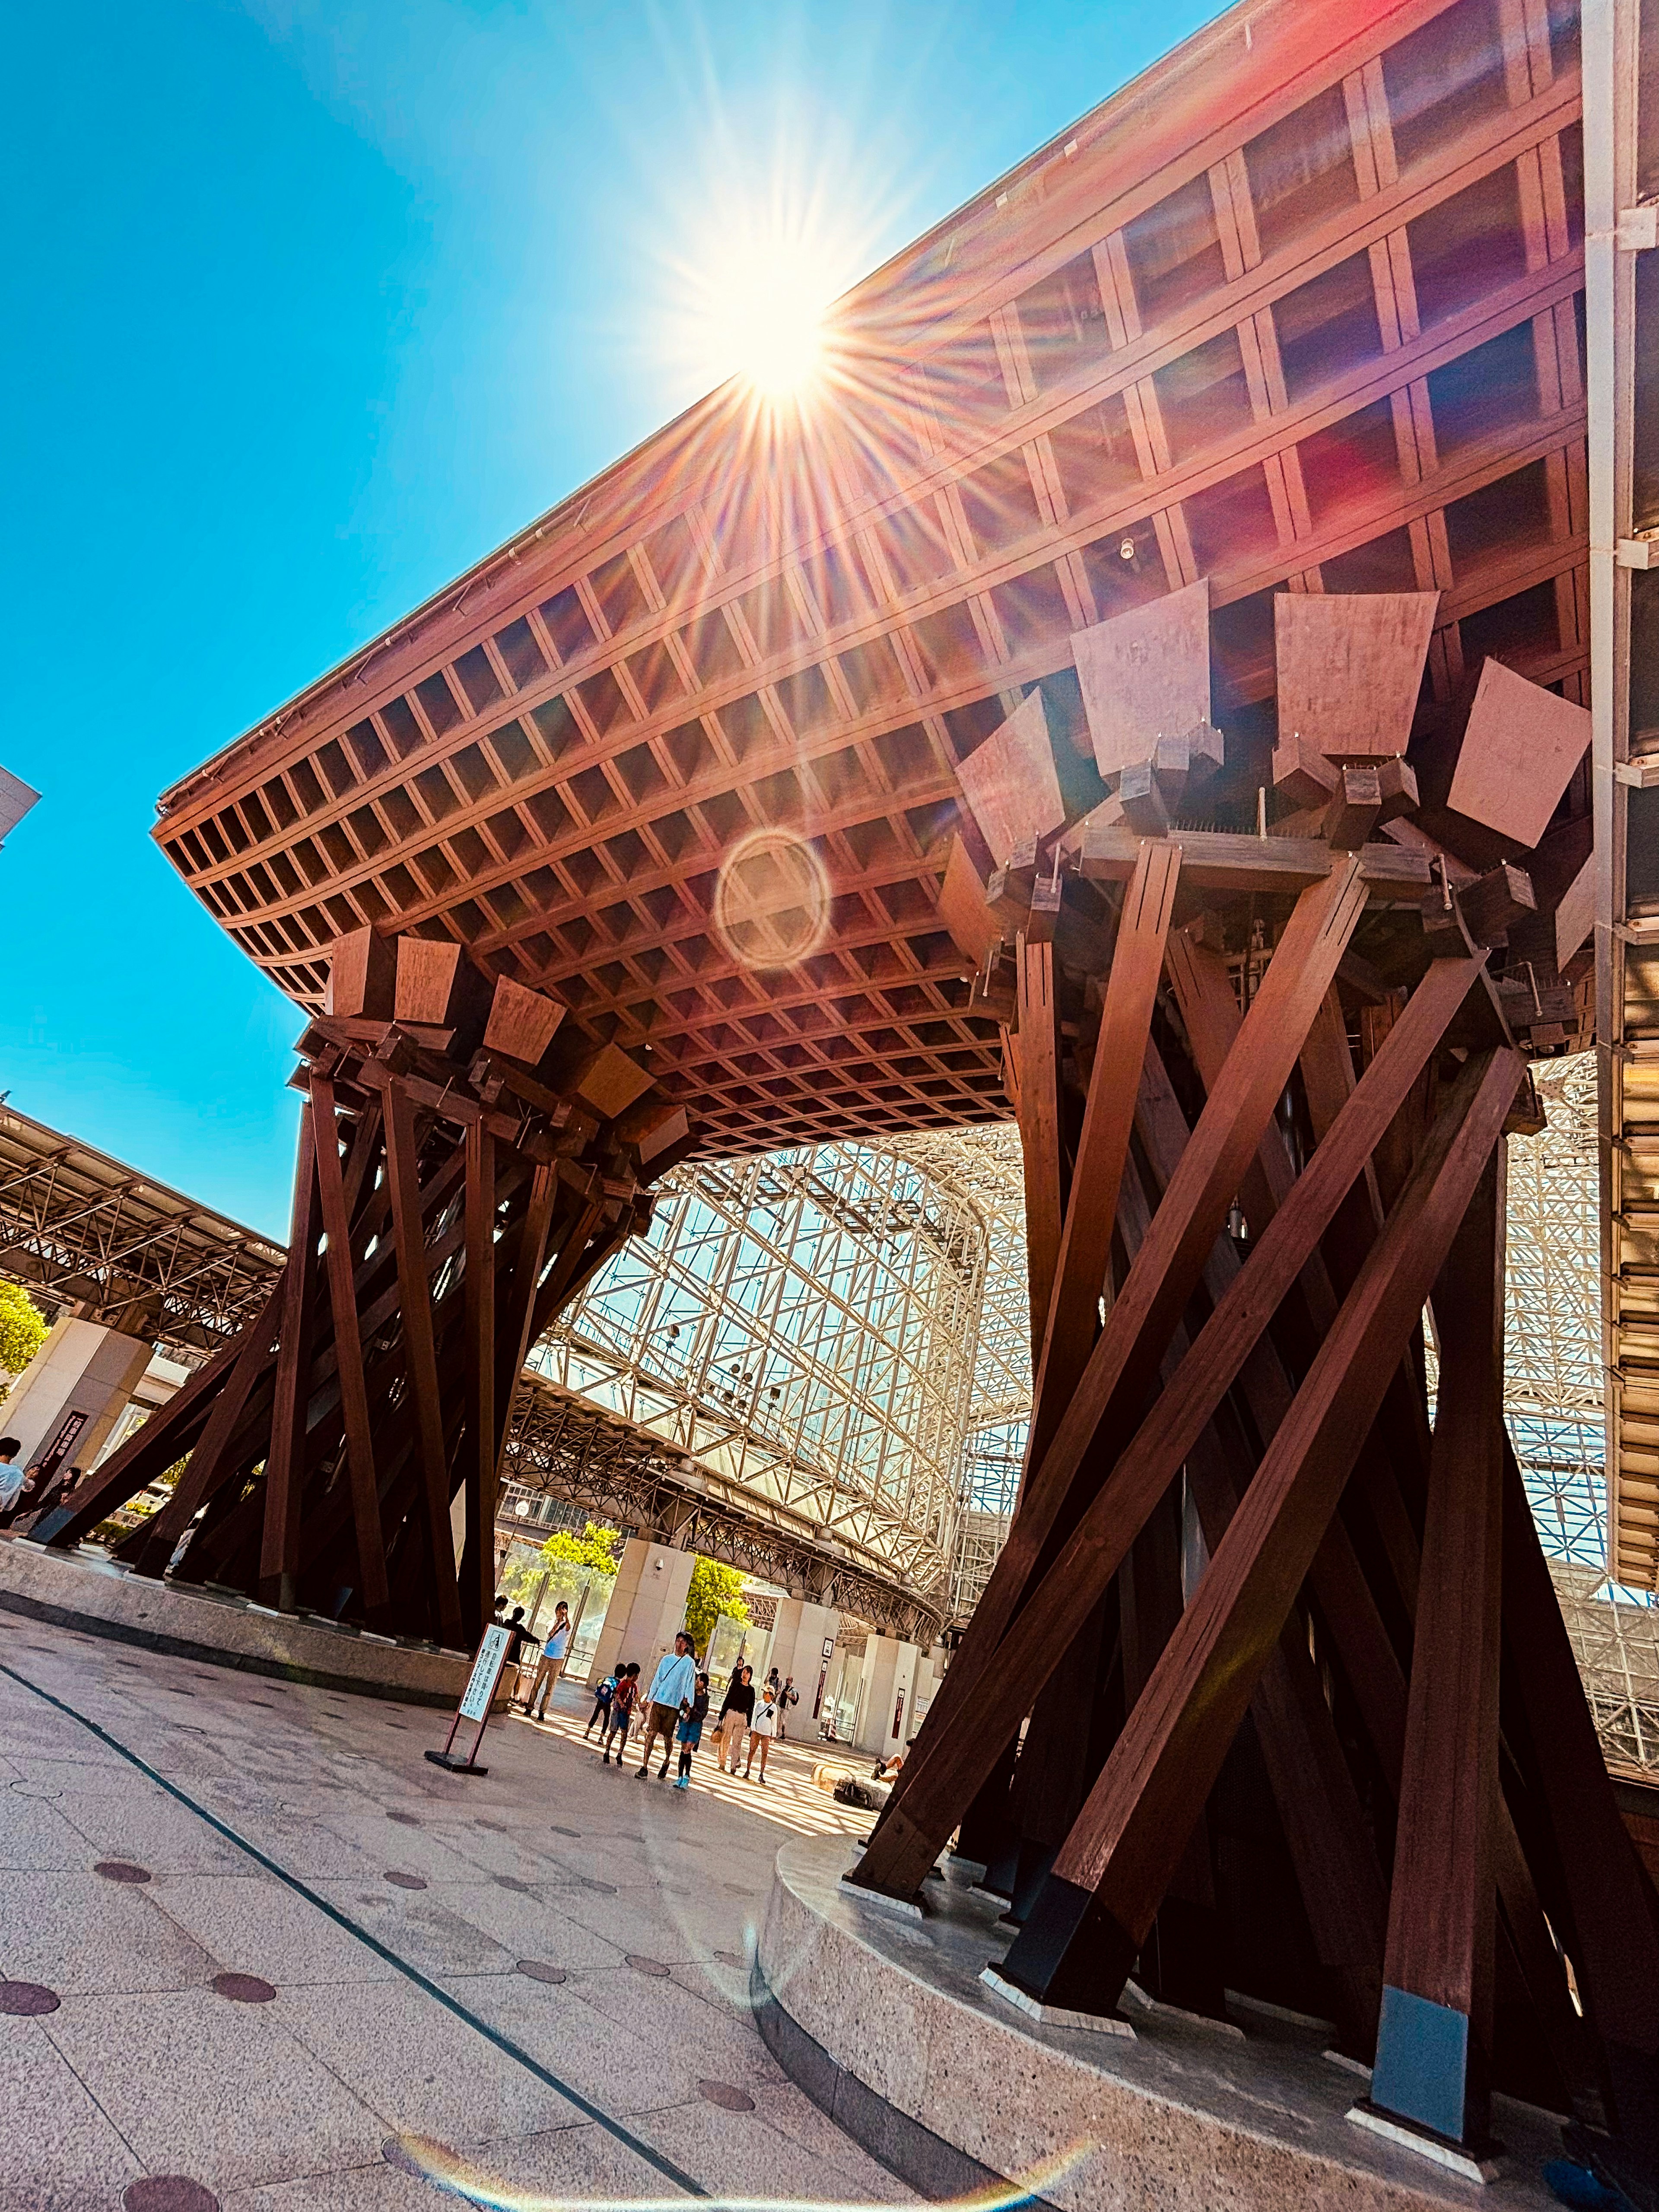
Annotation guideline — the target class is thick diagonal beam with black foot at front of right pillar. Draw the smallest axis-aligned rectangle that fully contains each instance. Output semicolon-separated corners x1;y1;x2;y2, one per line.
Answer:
1002;1039;1522;2011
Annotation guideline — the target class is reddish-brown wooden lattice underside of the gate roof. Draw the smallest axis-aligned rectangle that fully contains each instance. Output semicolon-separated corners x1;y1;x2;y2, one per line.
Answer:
157;0;1588;1153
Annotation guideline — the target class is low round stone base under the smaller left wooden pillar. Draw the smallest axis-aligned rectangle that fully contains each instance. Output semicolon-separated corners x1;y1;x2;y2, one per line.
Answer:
0;1537;471;1706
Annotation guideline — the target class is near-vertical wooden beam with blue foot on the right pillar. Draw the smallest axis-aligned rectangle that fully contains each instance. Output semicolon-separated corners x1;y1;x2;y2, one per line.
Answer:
1371;1141;1504;2148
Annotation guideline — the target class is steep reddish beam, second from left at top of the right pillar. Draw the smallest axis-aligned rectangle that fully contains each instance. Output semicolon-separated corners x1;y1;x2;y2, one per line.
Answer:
1020;841;1181;1467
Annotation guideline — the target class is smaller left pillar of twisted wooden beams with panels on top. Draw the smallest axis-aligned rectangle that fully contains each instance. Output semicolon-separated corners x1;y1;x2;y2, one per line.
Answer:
38;931;690;1646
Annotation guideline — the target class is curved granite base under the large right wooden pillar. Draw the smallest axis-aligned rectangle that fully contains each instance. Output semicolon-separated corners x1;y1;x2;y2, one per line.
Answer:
752;1836;1562;2212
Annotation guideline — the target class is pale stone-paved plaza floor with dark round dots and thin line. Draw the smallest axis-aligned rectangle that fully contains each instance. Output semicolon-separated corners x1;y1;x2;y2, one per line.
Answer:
0;1617;907;2212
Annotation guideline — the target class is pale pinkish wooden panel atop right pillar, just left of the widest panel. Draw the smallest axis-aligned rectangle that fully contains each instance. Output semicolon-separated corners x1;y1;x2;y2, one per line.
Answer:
1071;577;1210;776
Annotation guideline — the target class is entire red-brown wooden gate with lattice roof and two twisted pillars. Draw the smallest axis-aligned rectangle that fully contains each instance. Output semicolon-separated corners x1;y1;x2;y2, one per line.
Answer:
35;0;1659;2208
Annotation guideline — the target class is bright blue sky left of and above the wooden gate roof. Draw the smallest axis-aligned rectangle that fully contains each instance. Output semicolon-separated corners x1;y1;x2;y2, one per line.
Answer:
0;0;1214;1232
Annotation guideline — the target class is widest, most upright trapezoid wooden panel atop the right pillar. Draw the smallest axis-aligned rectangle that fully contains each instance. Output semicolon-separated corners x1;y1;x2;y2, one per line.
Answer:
1274;591;1440;783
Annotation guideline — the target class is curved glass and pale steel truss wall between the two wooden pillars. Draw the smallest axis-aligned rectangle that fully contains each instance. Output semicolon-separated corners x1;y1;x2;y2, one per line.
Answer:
531;1132;986;1619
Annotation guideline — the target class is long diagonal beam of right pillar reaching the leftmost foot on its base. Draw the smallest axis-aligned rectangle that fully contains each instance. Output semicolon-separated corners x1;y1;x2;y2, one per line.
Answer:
856;942;1480;1896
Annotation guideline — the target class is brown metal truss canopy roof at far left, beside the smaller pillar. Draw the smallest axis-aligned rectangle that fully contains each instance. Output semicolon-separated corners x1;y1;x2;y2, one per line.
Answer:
0;1108;285;1365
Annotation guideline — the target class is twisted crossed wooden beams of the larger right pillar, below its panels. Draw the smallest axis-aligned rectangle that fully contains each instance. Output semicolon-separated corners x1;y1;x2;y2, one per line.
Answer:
847;838;1659;2174
